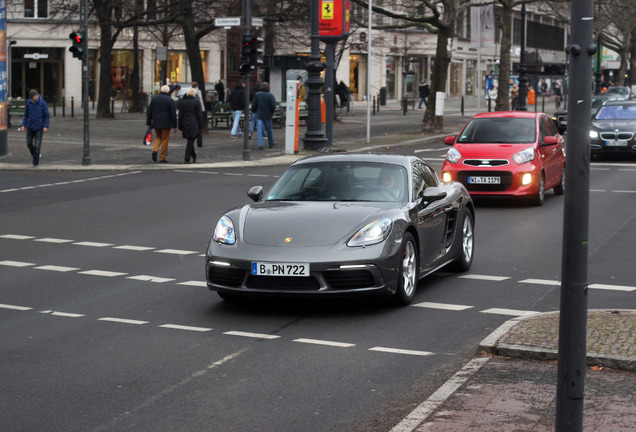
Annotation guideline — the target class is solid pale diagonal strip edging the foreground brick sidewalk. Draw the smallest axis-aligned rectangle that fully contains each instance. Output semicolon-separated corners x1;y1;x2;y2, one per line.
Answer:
390;357;489;432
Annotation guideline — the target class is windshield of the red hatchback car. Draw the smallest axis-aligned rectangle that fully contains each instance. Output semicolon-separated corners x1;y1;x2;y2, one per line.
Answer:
457;117;537;144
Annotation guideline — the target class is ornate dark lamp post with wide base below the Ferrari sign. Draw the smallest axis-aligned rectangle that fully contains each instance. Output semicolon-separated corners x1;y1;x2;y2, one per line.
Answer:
303;0;327;150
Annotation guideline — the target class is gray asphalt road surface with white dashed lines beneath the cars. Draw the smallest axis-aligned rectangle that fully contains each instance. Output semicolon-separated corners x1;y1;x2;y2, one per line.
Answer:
0;145;636;432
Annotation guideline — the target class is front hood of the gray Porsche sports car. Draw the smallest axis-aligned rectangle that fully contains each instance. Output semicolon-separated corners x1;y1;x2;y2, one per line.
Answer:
240;202;382;247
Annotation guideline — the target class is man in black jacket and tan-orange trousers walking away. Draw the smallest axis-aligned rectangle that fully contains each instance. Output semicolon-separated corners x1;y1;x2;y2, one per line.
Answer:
146;85;177;163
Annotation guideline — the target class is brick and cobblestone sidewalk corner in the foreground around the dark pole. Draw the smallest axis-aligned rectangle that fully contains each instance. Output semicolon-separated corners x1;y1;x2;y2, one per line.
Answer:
391;310;636;432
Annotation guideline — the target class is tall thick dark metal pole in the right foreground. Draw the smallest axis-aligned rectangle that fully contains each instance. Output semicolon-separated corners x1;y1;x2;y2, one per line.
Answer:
556;0;596;432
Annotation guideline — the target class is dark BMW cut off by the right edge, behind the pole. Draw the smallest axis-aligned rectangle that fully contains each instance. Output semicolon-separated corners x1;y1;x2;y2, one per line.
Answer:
590;100;636;155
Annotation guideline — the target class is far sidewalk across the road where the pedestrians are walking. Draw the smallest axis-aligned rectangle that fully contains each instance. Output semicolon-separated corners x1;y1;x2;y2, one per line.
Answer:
0;98;476;171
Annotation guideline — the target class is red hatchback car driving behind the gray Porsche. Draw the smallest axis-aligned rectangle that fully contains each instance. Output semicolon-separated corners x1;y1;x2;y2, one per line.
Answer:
442;111;565;205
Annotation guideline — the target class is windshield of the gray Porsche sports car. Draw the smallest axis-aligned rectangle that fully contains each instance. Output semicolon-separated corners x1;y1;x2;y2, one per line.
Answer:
266;162;407;202
